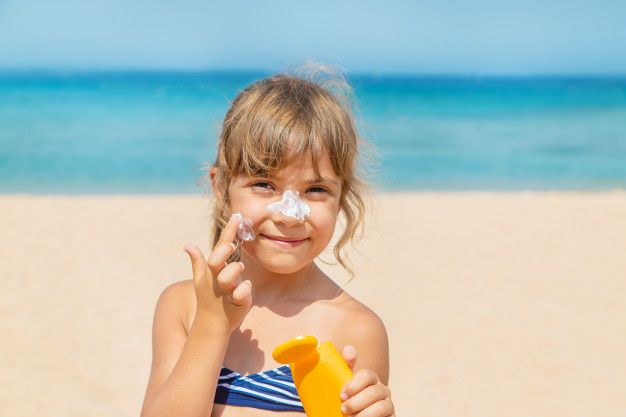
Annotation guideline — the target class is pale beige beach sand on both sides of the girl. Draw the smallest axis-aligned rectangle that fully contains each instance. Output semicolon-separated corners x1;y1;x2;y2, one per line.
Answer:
0;192;626;417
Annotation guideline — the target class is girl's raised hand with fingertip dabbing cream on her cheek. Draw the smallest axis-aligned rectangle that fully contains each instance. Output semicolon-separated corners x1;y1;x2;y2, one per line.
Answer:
185;217;252;335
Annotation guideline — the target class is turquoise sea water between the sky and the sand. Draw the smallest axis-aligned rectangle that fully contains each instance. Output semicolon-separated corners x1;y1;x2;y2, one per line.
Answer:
0;72;626;194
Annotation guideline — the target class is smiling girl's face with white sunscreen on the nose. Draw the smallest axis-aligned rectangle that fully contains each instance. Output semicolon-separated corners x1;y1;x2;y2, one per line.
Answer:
228;155;341;274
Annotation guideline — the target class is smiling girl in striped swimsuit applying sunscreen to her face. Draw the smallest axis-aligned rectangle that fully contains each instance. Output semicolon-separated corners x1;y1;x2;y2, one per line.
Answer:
141;66;394;417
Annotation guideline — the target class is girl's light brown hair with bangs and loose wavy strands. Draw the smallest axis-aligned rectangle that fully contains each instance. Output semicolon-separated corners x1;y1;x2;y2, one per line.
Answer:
205;64;368;277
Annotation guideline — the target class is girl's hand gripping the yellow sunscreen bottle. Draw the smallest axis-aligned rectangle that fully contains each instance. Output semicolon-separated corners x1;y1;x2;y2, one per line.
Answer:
341;345;395;417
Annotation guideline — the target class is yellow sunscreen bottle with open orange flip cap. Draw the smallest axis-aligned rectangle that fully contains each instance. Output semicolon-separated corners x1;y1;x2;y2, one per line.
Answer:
272;336;352;417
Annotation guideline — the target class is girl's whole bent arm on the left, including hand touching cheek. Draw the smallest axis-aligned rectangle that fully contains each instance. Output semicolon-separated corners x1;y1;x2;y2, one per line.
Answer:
141;216;252;417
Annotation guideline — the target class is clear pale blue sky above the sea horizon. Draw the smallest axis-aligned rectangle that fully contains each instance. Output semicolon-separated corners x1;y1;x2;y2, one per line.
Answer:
0;0;626;74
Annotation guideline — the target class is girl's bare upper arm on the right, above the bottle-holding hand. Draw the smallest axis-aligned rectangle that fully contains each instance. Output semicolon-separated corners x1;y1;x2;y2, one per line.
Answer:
324;293;389;384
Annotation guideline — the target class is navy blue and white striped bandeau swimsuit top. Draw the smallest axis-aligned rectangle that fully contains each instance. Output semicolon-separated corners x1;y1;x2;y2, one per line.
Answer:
214;365;304;412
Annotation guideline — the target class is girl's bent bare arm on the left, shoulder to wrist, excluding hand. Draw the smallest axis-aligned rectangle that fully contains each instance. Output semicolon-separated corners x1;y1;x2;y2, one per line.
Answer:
141;283;229;417
